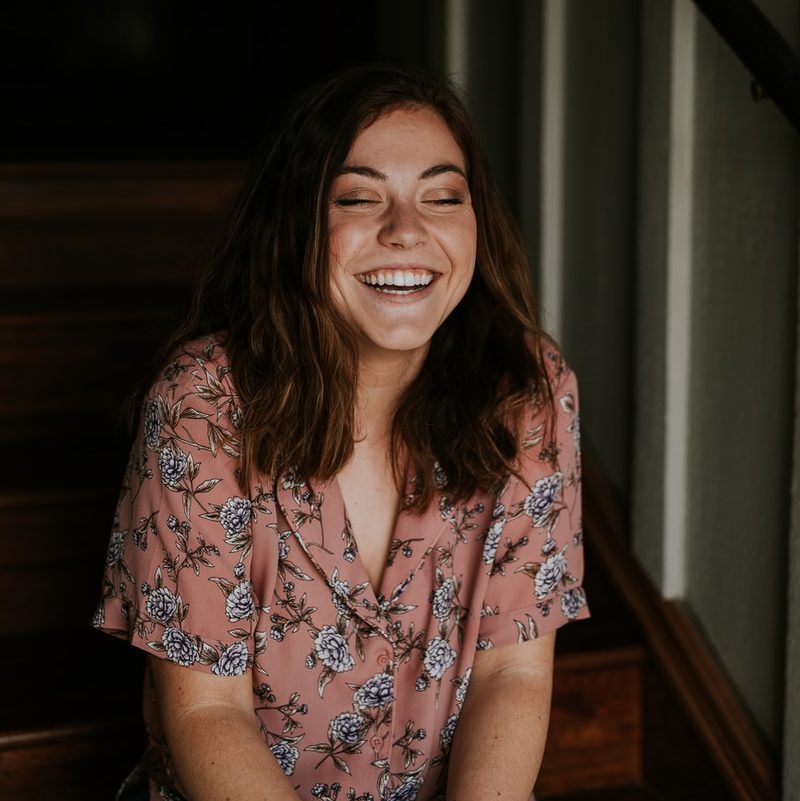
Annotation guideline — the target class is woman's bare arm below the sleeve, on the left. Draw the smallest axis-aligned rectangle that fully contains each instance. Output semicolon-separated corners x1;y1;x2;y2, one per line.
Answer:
150;657;299;801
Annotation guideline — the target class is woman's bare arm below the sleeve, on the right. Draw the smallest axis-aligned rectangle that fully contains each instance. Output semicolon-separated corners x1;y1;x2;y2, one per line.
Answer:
447;633;555;801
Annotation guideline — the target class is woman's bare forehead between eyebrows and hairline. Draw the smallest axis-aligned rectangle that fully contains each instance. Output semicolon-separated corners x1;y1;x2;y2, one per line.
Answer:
345;106;466;170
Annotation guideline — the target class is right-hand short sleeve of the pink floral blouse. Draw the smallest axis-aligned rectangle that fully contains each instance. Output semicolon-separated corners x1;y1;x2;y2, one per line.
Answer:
479;350;589;648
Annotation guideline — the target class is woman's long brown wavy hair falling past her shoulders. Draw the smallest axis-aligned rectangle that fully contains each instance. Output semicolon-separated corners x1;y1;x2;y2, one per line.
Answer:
160;65;552;510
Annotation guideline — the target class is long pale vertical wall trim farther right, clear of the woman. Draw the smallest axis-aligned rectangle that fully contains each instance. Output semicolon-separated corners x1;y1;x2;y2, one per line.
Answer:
663;0;696;598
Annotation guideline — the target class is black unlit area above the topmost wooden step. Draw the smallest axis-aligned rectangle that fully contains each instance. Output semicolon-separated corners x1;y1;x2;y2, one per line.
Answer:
0;0;441;160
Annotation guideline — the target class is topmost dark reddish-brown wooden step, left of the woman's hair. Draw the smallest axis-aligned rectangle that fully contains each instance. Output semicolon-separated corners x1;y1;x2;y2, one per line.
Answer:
0;162;244;293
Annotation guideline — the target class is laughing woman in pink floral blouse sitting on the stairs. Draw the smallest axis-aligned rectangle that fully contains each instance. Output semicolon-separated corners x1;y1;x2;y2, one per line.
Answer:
95;67;588;801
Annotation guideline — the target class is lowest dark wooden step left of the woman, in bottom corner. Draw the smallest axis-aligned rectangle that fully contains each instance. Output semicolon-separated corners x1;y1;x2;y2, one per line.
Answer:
0;625;145;801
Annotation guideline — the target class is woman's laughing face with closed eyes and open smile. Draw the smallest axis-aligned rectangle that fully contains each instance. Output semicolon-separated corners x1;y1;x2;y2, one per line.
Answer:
328;107;476;363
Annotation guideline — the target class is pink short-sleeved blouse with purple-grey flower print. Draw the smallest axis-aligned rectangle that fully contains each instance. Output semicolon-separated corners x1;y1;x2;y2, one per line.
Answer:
94;340;588;801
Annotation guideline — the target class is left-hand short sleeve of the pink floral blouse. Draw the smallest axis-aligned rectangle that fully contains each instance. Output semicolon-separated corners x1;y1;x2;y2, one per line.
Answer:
93;342;272;675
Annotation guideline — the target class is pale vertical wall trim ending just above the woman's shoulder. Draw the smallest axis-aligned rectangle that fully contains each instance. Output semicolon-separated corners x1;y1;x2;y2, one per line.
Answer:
540;0;568;340
